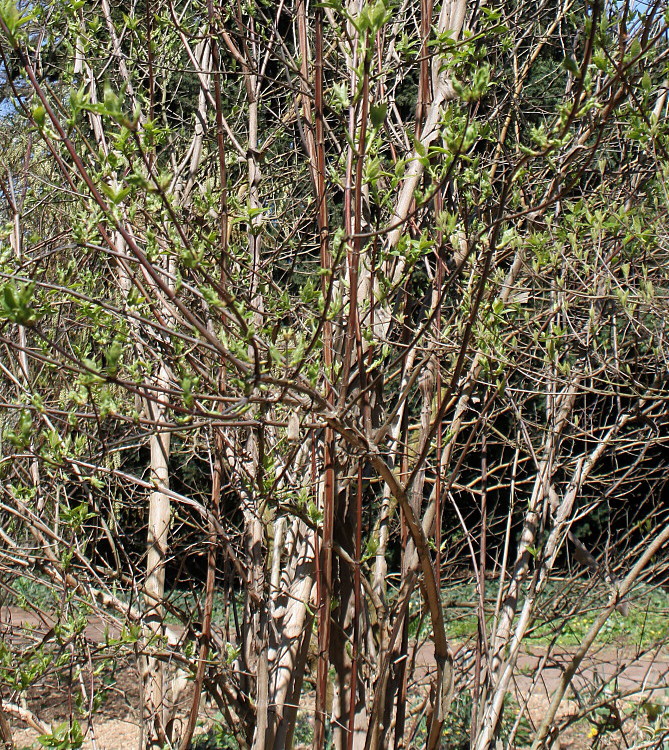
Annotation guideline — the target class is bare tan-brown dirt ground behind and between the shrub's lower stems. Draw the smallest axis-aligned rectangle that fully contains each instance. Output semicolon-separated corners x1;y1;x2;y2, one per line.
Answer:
0;608;669;750
